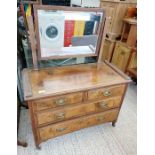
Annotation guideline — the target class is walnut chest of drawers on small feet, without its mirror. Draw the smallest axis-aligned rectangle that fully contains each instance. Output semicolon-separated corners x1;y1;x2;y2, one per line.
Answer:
22;62;130;148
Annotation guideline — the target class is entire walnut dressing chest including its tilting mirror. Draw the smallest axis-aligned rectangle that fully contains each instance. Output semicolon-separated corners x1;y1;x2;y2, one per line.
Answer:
22;5;130;148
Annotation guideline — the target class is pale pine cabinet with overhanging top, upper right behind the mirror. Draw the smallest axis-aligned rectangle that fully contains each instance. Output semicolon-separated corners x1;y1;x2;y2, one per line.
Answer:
100;0;136;40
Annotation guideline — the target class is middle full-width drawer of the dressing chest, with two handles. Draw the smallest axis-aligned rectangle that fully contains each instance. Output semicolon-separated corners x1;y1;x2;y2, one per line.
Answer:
36;97;121;125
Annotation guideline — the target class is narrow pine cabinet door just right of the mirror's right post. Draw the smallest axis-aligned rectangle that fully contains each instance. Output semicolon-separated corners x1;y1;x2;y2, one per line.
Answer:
102;39;116;62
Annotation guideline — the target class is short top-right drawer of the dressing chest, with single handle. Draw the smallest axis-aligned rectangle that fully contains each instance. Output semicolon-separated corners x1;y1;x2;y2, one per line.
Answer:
88;85;125;100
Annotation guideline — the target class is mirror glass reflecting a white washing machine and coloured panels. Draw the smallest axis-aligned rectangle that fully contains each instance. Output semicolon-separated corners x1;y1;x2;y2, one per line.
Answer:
37;10;103;58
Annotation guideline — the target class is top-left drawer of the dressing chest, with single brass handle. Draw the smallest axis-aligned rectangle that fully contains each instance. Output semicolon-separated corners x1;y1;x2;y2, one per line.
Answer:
33;93;83;111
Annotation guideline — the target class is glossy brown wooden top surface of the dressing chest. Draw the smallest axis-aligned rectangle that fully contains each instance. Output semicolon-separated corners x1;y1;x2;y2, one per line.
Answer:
22;63;130;100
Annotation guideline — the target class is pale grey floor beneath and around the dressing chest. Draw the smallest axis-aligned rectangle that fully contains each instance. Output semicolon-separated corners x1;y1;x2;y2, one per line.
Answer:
17;83;137;155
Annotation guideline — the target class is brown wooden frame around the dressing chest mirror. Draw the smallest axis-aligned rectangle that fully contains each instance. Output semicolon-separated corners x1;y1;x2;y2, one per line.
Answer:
33;5;106;60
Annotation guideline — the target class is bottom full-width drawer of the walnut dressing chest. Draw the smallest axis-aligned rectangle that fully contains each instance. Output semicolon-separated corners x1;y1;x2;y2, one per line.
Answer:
38;109;119;141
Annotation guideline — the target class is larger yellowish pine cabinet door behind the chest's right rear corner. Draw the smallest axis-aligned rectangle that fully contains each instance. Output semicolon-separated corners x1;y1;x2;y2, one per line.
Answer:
111;42;132;72
